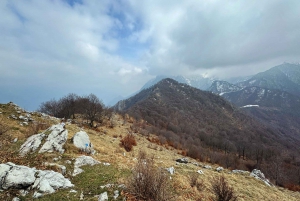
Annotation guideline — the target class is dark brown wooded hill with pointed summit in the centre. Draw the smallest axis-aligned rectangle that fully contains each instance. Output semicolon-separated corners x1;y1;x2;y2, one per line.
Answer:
115;79;299;185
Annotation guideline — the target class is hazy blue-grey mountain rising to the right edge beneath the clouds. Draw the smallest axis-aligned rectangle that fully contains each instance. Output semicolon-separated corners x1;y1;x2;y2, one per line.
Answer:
237;63;300;96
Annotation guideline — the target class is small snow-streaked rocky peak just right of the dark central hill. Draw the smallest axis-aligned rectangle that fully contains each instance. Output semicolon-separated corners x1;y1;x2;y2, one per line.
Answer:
208;80;242;95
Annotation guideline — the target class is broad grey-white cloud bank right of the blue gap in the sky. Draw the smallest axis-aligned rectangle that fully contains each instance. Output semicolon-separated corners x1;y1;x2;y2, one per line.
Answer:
124;0;300;74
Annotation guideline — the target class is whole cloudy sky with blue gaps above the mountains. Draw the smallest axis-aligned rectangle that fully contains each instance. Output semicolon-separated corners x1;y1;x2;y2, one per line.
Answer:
0;0;300;110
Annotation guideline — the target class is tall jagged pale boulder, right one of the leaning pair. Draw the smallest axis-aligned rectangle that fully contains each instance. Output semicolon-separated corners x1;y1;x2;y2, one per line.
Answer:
39;124;68;154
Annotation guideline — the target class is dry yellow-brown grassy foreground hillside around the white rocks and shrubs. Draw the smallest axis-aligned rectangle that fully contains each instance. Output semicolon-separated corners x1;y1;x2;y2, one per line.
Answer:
0;103;300;201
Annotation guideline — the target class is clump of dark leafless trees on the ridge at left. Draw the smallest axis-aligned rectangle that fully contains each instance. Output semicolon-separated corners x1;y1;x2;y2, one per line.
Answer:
38;93;111;126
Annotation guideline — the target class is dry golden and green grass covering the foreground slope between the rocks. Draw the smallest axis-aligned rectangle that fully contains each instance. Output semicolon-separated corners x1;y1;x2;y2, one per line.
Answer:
0;105;300;201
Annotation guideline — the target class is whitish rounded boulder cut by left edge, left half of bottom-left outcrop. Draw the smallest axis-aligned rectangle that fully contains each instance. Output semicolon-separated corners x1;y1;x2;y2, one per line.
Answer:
1;163;36;189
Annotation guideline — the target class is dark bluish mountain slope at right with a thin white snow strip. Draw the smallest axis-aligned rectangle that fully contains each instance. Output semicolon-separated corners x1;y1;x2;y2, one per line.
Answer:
222;87;300;143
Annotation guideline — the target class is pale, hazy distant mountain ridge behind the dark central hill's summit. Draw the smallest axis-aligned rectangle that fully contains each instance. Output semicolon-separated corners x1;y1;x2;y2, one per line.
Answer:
141;75;214;90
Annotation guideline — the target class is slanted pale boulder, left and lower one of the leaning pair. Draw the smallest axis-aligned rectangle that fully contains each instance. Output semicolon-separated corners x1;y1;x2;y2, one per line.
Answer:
20;133;45;156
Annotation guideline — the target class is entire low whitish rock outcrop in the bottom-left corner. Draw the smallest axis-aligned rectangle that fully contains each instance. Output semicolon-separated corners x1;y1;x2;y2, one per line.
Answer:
0;163;74;198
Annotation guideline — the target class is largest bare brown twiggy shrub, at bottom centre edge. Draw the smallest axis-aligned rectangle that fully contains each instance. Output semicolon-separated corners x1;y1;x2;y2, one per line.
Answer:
127;151;172;201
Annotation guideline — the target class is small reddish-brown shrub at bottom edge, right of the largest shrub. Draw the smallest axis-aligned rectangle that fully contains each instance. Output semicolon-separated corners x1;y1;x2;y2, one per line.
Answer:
211;176;238;201
